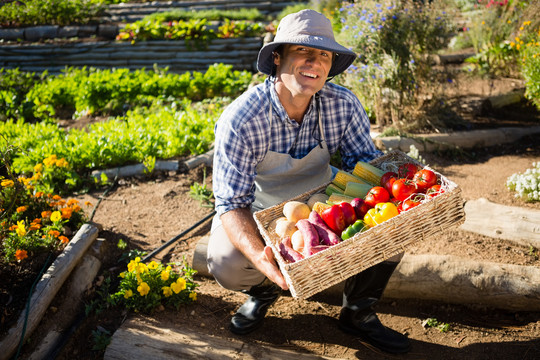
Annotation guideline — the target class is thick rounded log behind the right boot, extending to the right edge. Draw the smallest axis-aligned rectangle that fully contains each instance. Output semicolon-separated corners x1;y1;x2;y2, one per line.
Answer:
384;254;540;311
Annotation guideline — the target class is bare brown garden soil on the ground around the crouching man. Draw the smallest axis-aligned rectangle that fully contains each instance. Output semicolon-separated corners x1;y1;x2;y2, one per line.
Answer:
4;78;540;360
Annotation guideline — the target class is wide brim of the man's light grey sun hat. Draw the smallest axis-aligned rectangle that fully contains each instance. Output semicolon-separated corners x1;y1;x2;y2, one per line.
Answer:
257;39;356;77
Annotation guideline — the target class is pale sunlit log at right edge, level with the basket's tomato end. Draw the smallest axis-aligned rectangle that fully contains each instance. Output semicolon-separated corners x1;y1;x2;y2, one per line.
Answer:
461;198;540;249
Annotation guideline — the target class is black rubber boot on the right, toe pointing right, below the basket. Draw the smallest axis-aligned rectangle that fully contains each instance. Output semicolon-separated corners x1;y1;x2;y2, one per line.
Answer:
339;262;410;354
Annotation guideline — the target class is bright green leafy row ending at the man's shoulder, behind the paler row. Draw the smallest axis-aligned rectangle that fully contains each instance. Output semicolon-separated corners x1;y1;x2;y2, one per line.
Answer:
7;64;252;122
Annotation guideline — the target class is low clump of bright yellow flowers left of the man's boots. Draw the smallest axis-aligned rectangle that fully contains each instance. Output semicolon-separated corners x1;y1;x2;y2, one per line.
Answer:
109;257;198;313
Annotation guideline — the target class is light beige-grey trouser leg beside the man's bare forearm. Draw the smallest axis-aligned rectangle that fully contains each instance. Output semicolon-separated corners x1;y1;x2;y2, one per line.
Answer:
206;218;265;291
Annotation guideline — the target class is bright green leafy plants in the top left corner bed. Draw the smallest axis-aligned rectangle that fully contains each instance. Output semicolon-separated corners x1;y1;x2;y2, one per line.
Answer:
0;0;104;27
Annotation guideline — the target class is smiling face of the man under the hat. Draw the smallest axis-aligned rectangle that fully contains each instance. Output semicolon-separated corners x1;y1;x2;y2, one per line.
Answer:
274;45;333;97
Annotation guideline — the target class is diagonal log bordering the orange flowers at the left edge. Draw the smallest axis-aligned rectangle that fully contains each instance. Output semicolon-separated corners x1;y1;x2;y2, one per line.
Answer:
0;224;99;358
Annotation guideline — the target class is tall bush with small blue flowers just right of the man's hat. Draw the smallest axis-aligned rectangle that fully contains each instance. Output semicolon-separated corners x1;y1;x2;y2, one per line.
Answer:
337;0;452;126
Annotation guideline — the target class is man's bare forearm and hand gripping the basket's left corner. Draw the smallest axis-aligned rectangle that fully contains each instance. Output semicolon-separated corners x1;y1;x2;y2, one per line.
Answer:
221;209;289;290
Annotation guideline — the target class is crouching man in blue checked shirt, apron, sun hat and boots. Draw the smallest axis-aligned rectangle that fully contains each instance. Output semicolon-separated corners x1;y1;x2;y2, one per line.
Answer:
207;10;409;353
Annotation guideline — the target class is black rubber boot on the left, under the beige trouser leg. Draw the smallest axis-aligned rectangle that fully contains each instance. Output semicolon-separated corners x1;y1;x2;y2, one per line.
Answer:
230;279;282;335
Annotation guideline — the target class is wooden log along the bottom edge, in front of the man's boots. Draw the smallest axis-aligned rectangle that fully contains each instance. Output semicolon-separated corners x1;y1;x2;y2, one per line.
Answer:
103;319;333;360
